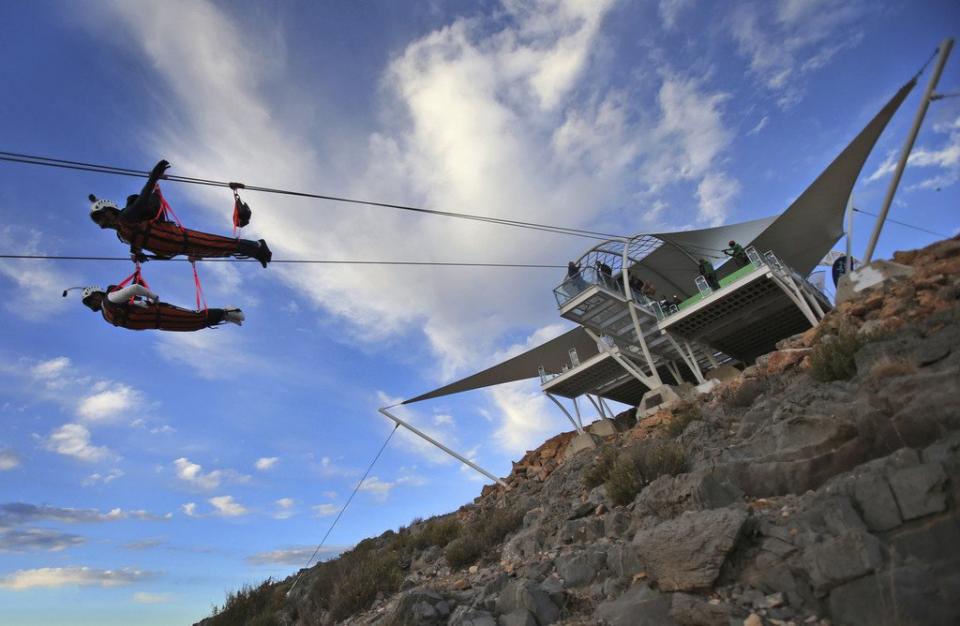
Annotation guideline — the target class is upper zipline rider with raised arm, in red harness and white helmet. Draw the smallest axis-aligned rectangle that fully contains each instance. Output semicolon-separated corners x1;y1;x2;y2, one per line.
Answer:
90;161;273;267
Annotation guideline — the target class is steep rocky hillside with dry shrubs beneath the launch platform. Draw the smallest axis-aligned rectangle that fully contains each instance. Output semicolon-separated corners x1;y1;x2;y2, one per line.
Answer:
202;238;960;626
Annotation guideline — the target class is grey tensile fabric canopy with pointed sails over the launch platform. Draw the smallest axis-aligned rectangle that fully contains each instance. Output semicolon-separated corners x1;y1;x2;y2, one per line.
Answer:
403;78;916;404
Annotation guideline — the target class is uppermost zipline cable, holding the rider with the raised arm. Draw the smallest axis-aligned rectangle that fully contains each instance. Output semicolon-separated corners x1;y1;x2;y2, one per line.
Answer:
0;151;621;241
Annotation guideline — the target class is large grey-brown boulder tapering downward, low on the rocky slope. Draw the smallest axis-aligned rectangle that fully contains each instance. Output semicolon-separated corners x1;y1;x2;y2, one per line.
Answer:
633;506;748;591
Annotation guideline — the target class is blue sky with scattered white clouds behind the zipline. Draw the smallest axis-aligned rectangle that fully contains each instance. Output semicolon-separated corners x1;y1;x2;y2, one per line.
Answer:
0;0;960;625
